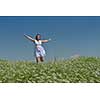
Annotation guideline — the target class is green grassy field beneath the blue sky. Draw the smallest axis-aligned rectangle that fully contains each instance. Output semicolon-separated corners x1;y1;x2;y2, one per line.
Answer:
0;57;100;83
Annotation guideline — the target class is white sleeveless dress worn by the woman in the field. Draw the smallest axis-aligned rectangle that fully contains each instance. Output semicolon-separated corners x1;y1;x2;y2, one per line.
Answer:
34;40;46;57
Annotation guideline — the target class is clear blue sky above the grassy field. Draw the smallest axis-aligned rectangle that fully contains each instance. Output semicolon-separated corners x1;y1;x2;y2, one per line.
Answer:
0;16;100;60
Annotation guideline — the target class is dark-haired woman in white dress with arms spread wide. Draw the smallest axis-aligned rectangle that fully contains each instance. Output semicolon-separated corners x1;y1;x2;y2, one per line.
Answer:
24;34;51;63
